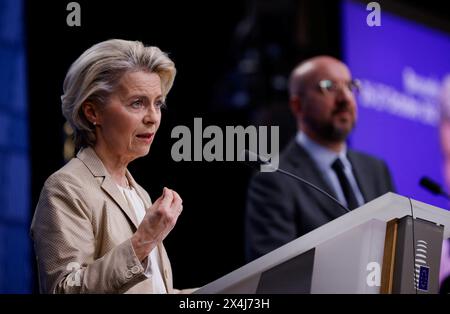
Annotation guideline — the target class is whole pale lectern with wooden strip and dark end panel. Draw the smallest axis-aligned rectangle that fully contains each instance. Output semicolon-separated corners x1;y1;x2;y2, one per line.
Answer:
196;193;450;294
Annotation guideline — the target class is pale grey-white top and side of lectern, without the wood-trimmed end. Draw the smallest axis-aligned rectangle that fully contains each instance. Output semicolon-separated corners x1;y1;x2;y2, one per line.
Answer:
196;193;450;294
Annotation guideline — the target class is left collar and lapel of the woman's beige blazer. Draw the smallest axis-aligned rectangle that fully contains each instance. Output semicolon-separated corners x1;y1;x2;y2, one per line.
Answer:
77;147;138;228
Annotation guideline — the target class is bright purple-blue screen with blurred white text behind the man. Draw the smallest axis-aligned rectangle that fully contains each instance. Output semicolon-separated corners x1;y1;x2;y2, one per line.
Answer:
342;1;450;208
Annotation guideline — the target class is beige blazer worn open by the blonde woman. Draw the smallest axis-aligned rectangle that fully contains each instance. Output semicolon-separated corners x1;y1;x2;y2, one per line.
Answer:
31;148;178;293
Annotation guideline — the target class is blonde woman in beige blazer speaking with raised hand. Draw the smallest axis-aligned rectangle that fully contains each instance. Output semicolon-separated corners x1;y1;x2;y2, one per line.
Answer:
31;39;189;293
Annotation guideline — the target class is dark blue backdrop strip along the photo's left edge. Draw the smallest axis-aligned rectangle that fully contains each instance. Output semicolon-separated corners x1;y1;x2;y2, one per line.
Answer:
0;0;31;293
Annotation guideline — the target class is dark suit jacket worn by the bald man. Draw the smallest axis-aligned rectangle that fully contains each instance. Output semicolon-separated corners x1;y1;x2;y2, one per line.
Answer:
245;140;395;261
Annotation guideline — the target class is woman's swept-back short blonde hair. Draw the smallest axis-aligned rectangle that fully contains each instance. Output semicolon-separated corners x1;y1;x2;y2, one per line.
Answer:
61;39;176;147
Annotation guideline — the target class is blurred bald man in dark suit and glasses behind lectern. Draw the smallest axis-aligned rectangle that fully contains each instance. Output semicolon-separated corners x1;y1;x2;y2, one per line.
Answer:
245;56;394;261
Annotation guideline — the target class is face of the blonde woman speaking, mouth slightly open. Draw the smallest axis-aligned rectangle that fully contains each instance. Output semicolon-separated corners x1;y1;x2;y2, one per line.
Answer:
96;71;164;161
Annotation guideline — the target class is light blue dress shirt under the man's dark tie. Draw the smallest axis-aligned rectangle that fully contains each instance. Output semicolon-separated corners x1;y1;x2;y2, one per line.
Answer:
296;132;364;206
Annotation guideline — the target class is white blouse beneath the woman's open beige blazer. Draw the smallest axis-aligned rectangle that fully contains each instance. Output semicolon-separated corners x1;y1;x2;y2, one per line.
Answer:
117;185;167;294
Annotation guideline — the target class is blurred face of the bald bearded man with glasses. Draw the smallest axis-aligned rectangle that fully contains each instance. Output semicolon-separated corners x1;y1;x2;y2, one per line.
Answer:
300;60;357;142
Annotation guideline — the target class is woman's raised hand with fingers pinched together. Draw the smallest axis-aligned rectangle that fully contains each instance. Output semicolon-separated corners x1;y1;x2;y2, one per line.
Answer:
131;188;183;261
